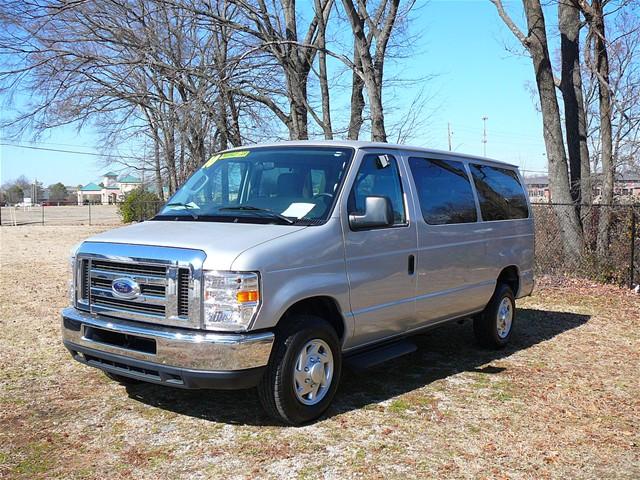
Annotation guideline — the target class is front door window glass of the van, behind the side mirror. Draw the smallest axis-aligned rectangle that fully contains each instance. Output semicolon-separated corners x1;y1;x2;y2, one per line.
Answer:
349;154;406;224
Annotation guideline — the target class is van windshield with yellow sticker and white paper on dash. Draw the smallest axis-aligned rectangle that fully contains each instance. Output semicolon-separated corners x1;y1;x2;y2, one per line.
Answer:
154;147;353;225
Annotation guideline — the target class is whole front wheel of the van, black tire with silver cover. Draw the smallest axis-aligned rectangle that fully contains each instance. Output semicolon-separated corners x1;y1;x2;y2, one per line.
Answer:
258;315;342;425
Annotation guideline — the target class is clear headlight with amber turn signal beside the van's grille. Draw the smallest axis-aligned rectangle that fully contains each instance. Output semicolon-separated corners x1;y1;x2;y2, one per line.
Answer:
204;271;260;331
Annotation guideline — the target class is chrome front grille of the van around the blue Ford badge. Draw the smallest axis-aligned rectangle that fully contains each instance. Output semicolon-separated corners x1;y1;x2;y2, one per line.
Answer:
76;243;204;328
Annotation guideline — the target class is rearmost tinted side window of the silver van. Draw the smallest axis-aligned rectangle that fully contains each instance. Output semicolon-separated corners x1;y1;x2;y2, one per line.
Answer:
469;164;529;220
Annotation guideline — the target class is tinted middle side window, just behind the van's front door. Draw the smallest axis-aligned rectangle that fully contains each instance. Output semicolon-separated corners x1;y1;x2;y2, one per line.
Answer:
409;157;478;225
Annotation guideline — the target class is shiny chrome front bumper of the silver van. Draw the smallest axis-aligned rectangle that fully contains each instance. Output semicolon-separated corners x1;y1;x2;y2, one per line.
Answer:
62;307;274;372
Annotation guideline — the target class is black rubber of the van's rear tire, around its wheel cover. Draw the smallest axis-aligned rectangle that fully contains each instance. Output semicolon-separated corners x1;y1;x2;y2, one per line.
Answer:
473;283;516;348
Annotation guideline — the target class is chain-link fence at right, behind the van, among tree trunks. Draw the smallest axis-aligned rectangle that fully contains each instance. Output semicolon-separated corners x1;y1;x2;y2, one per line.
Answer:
532;203;640;287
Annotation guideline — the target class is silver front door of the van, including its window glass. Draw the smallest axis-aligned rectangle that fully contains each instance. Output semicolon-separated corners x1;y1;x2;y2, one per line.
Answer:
342;152;417;346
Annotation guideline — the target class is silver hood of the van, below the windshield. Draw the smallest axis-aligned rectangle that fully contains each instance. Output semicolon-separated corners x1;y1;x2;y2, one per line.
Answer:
86;221;307;270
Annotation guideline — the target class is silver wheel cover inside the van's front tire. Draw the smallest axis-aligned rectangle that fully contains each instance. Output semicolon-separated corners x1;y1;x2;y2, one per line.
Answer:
293;338;333;405
